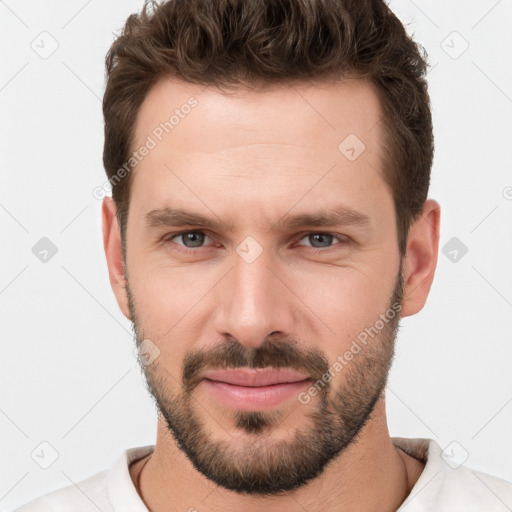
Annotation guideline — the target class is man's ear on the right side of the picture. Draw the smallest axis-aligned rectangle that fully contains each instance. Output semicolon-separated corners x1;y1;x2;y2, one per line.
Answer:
400;199;441;317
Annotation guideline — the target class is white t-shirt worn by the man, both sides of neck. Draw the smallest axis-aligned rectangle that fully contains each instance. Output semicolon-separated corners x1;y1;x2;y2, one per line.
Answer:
11;437;512;512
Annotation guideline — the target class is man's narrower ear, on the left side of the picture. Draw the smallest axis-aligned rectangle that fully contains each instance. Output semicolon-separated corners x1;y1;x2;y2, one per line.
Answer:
101;196;131;320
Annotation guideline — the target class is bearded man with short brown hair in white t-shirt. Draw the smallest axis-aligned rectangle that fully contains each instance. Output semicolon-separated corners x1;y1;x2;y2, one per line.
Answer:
14;0;512;512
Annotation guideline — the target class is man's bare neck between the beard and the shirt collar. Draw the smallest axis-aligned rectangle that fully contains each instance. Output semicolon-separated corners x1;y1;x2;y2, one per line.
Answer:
130;400;424;512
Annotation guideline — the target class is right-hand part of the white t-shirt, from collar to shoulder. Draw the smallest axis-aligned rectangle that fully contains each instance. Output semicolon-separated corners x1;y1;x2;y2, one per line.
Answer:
393;438;512;512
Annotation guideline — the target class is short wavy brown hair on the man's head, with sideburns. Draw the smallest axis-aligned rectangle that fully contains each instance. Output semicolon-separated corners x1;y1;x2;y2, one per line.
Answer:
103;0;434;256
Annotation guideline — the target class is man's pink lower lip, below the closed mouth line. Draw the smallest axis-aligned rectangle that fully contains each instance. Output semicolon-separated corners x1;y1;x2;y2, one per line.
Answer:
202;379;309;411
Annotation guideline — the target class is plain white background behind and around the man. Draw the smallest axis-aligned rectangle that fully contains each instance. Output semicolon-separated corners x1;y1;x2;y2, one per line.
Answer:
0;0;512;510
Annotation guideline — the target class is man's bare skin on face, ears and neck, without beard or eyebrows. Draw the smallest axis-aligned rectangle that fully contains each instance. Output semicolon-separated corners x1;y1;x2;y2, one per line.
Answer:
103;79;440;512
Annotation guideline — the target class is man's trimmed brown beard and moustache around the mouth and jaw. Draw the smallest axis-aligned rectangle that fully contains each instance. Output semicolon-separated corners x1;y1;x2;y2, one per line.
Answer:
126;269;404;496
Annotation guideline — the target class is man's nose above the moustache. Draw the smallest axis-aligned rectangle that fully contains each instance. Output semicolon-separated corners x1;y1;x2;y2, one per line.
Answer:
215;243;294;348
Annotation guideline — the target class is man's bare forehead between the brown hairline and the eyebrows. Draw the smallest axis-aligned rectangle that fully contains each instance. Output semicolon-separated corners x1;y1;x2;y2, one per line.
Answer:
130;79;390;230
